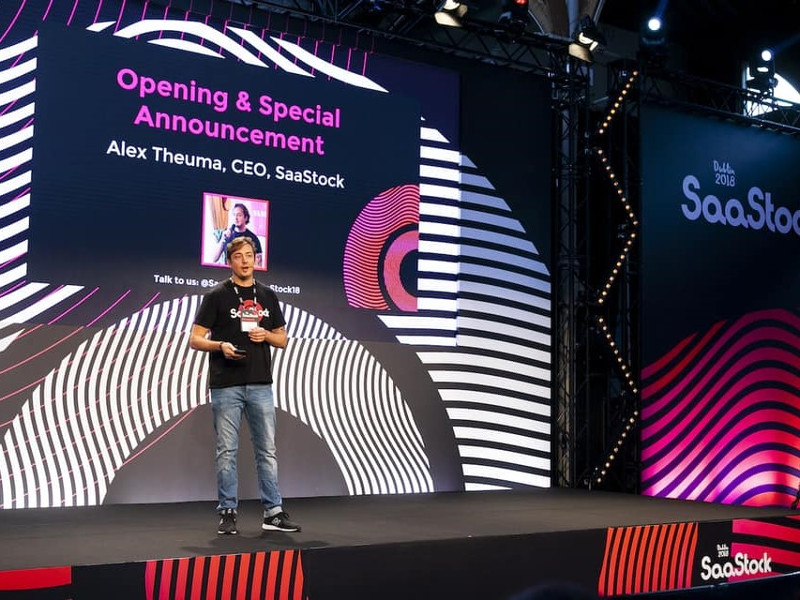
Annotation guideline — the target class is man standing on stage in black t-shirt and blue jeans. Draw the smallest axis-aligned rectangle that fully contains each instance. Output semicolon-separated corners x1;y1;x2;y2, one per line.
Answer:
189;236;300;535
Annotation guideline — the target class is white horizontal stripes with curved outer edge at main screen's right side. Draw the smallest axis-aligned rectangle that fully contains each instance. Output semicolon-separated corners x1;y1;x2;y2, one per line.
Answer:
383;143;551;489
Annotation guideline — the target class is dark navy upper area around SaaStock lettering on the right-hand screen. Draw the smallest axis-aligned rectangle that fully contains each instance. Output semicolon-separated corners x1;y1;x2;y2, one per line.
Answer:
642;106;800;365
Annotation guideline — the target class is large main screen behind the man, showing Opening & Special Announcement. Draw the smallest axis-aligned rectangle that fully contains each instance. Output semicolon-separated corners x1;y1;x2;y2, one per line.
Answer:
0;0;551;508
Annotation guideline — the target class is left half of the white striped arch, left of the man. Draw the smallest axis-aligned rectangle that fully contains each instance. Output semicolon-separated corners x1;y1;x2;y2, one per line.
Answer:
0;299;212;508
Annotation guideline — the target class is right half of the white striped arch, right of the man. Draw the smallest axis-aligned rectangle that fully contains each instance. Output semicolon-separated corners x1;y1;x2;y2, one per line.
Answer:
274;339;433;494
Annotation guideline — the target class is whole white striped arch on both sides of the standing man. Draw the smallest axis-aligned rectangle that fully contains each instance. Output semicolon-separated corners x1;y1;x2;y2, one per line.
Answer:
0;296;433;508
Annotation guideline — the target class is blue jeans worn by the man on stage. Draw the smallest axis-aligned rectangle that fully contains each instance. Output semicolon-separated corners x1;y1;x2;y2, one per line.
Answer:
211;384;281;511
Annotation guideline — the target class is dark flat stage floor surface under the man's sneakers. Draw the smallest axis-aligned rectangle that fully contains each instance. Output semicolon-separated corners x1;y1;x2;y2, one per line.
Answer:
0;489;796;571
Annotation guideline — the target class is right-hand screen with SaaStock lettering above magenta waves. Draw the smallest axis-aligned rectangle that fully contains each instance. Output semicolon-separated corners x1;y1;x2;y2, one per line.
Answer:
642;107;800;506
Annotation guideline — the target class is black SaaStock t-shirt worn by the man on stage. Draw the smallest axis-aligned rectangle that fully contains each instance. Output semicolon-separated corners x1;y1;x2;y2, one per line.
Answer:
194;280;286;388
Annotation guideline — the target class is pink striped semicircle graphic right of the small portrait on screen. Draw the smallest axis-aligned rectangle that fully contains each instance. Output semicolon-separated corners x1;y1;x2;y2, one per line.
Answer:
342;184;419;312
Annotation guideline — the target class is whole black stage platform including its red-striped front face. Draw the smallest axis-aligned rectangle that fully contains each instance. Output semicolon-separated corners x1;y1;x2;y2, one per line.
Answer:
0;489;800;600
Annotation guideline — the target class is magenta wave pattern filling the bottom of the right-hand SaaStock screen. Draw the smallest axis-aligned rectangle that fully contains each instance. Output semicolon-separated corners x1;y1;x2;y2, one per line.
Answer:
642;309;800;506
